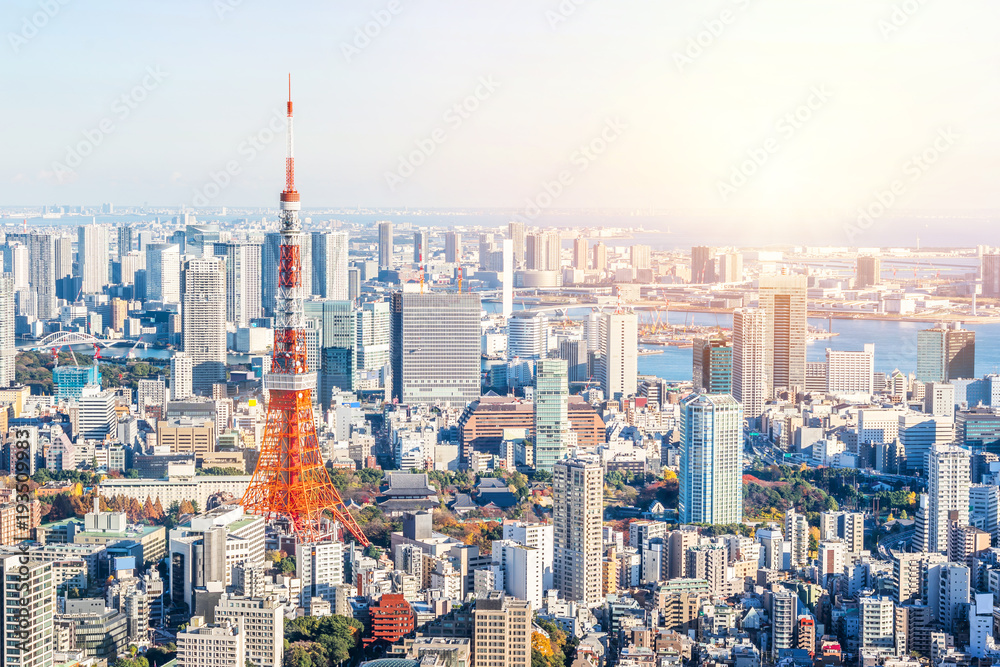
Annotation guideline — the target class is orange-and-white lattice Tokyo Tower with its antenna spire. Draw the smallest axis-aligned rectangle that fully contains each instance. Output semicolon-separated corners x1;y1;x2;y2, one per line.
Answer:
240;75;369;546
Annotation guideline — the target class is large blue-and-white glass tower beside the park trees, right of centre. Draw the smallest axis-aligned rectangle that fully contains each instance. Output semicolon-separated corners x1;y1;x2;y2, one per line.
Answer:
678;394;743;524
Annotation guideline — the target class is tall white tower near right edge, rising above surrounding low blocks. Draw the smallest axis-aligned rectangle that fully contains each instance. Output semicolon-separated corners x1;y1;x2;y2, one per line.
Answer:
927;445;970;553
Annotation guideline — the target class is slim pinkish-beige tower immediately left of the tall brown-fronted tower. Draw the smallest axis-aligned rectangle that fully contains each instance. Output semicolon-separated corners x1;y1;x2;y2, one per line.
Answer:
733;308;770;424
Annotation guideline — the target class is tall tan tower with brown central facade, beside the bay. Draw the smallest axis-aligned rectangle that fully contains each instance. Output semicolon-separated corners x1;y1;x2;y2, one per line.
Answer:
759;275;807;391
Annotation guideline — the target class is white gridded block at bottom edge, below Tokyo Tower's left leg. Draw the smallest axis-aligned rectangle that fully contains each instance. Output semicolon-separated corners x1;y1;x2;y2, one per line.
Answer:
215;596;284;667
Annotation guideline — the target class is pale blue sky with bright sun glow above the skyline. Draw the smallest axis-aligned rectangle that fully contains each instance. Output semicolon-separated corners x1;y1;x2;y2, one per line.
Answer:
0;0;1000;215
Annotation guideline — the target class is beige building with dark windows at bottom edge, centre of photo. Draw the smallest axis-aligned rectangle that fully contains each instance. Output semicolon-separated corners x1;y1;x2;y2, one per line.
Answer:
472;591;532;667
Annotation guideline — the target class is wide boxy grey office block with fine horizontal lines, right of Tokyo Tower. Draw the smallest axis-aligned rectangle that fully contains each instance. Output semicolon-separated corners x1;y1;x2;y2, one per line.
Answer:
392;292;482;406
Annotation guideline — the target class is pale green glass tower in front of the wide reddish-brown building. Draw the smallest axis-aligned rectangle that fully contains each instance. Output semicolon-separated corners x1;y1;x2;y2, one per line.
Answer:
535;359;569;472
